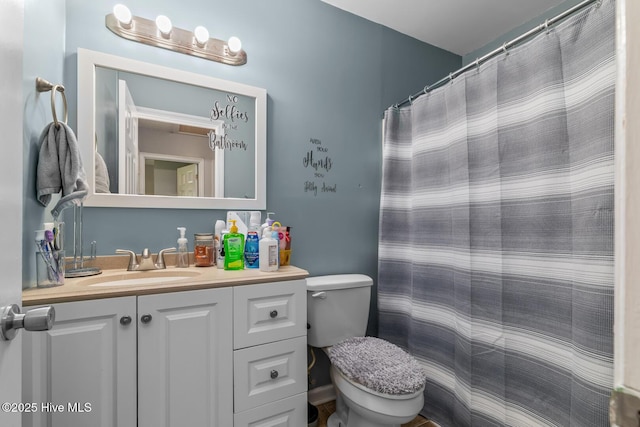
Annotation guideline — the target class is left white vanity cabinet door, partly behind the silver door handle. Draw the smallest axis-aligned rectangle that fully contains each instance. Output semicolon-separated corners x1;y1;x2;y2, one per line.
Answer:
22;297;136;427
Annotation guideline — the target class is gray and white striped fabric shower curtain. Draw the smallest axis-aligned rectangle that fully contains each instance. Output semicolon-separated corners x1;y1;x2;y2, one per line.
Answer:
378;0;615;427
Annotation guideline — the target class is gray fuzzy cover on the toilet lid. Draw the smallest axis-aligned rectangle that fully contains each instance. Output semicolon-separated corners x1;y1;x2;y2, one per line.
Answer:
329;337;427;395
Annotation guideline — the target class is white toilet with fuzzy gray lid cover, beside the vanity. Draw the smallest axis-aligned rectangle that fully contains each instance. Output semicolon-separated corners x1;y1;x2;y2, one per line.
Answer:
307;274;426;427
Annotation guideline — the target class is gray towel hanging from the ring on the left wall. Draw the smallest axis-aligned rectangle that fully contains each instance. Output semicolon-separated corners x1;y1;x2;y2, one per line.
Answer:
36;122;89;218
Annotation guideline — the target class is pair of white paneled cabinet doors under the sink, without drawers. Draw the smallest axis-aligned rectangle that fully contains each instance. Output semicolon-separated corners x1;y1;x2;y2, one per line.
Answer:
23;288;233;427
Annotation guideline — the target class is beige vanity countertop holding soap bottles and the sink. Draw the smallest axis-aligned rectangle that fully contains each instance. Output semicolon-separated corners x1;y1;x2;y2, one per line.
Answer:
22;265;309;306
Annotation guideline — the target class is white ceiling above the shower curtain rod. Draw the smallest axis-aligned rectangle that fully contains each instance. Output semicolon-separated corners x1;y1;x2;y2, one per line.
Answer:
322;0;564;56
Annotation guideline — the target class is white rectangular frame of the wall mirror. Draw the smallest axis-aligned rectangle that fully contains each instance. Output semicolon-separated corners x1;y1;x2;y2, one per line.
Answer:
78;48;267;210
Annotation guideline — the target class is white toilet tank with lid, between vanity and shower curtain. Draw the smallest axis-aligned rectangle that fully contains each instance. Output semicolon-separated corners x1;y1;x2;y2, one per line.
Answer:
307;274;373;347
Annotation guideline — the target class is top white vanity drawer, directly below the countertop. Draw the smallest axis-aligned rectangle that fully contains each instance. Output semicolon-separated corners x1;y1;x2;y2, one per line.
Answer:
233;280;307;349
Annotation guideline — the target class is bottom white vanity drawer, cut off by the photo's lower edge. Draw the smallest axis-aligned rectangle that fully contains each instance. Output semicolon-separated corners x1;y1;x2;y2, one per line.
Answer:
233;393;308;427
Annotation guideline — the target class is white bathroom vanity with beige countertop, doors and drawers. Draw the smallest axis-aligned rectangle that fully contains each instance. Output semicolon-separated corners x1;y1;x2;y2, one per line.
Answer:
23;266;308;427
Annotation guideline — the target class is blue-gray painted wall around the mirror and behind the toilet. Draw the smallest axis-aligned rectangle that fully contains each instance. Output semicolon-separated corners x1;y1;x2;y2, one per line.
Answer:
24;0;461;310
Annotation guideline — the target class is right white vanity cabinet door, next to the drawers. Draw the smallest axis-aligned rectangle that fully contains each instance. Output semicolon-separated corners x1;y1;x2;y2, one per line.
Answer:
138;288;233;427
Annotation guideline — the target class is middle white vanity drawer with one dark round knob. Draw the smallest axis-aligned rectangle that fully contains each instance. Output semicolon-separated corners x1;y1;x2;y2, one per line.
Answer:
233;336;307;413
